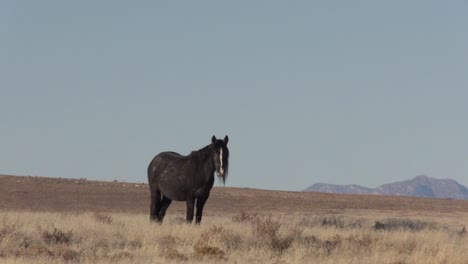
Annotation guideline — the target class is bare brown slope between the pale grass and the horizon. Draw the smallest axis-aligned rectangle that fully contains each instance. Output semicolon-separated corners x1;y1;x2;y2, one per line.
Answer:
0;175;468;217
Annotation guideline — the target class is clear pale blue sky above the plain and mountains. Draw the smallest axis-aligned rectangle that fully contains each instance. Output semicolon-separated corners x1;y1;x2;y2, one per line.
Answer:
0;0;468;190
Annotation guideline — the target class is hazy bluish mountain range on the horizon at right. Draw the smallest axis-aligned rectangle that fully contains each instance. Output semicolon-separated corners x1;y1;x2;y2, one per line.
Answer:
304;175;468;200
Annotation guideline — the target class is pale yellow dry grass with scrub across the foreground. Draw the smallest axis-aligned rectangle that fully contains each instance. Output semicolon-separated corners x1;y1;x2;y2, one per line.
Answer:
0;209;468;264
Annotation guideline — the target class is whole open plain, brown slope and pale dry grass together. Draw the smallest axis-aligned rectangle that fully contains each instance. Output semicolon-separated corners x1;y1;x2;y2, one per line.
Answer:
0;176;468;264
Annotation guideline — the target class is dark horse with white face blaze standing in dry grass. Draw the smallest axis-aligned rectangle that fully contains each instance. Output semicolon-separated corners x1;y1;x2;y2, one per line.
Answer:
148;136;229;224
